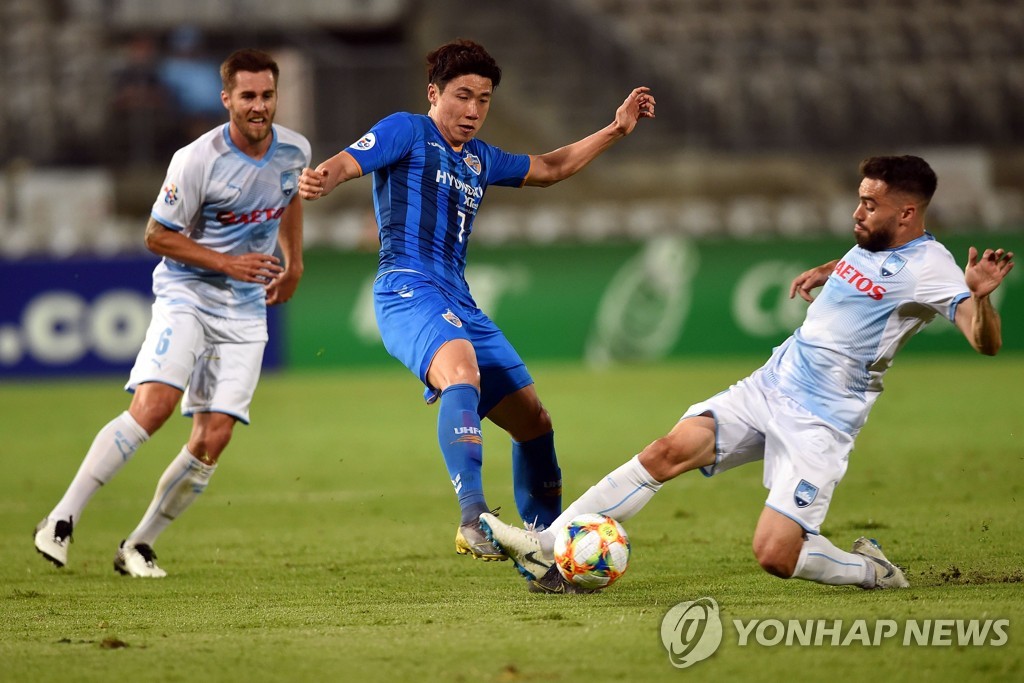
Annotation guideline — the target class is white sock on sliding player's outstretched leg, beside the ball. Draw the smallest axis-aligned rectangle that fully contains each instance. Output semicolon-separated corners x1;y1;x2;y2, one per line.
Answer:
540;456;662;554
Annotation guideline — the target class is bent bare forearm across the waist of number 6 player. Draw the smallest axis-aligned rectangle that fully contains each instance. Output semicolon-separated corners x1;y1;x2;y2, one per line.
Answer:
145;217;284;284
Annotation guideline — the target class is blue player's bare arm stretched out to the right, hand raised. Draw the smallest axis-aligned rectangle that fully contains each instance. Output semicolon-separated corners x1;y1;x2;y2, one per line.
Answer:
526;86;655;187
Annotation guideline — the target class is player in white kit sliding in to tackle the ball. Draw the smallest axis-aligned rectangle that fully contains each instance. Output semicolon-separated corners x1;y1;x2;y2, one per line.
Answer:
480;156;1014;592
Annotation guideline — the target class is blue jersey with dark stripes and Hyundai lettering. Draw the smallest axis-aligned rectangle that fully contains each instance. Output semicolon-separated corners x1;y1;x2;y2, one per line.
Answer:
346;113;529;305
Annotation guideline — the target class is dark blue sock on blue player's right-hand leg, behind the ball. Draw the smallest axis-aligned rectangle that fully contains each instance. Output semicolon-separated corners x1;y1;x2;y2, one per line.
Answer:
512;432;562;529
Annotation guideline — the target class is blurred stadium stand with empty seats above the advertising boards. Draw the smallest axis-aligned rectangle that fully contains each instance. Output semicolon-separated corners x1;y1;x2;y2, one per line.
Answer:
0;0;1024;257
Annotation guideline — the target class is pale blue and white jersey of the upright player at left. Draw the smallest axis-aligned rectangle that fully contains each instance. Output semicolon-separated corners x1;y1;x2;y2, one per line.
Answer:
152;124;311;318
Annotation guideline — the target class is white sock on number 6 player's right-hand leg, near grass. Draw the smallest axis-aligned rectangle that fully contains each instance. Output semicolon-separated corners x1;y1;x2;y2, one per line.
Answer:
127;445;217;546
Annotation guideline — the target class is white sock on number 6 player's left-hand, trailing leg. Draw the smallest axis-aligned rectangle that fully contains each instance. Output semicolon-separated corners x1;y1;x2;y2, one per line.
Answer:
49;411;150;523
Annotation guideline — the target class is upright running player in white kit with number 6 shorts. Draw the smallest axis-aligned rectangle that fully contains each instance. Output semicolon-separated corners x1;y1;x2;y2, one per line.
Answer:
35;49;311;578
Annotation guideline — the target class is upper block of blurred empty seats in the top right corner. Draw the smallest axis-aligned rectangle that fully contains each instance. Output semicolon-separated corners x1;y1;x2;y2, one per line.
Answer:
574;0;1024;151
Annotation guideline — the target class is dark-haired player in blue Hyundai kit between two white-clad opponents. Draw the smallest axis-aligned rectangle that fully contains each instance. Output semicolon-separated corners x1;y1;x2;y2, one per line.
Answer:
299;40;654;560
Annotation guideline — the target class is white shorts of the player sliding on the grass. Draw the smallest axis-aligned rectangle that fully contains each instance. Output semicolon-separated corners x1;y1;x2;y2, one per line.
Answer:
682;371;854;533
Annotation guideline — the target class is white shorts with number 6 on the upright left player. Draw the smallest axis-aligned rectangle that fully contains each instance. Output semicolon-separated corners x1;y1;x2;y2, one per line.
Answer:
125;301;267;424
